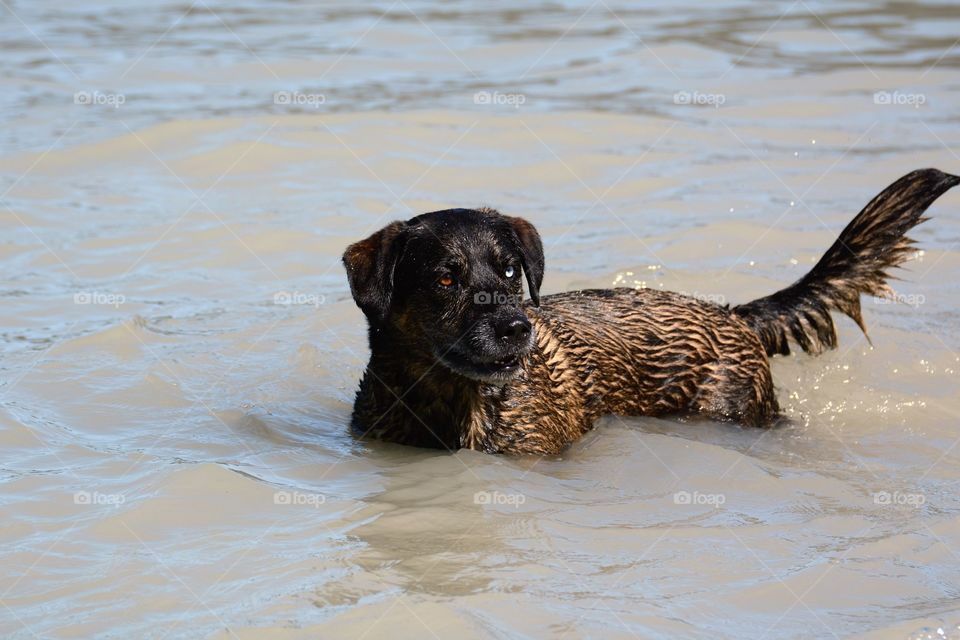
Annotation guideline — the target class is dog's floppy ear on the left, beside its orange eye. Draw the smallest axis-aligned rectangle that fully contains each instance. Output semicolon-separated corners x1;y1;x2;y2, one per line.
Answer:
343;222;407;325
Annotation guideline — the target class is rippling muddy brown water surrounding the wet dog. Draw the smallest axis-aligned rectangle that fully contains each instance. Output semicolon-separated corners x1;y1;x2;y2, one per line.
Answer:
0;0;960;638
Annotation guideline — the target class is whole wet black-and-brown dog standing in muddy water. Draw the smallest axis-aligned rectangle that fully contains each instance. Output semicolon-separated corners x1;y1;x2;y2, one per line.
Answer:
343;169;960;454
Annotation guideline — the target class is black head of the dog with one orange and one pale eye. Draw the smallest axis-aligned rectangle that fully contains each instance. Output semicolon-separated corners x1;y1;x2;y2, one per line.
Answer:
343;209;543;383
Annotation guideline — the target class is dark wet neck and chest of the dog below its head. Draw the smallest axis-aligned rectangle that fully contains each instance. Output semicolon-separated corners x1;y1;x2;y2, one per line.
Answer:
355;329;502;450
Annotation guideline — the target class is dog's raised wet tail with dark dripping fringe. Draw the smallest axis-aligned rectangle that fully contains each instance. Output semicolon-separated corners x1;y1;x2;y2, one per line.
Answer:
733;169;960;355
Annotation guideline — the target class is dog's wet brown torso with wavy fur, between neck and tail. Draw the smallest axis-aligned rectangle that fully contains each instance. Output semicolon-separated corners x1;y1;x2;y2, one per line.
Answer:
465;289;777;453
